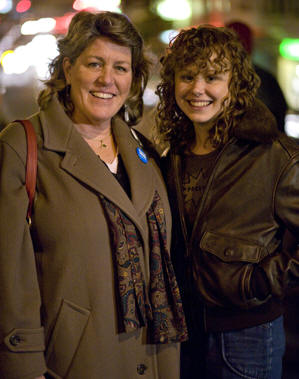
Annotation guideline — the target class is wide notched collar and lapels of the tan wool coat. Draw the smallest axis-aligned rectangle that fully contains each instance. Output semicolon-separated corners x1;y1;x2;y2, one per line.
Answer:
40;98;155;235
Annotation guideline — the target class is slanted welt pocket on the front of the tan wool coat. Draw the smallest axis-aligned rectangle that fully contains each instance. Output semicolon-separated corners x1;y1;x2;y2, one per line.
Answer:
46;300;90;378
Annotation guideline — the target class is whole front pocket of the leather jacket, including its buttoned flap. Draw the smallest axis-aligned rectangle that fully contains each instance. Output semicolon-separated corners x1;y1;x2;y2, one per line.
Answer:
196;231;268;309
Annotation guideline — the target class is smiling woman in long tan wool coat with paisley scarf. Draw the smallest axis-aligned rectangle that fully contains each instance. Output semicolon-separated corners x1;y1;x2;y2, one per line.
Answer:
0;12;186;379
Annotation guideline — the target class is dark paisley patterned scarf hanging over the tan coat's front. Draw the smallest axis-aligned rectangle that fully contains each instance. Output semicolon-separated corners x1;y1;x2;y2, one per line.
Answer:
101;192;187;343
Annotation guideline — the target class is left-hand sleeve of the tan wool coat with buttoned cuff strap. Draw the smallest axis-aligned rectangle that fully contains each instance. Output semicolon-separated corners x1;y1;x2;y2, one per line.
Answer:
0;127;46;379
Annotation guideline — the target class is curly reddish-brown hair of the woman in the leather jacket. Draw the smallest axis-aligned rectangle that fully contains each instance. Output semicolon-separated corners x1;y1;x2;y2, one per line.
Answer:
154;25;260;150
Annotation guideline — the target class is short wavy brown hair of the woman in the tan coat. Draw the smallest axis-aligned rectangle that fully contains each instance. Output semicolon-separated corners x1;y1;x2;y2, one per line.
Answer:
38;11;151;125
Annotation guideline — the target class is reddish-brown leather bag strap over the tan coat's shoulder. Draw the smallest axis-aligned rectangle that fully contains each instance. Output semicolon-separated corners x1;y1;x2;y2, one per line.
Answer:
15;120;37;226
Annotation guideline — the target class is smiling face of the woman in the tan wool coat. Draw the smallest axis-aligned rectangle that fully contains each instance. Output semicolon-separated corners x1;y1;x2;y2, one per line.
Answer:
63;38;132;128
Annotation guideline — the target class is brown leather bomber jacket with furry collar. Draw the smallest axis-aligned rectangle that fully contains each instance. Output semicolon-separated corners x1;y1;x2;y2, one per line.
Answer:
165;102;299;329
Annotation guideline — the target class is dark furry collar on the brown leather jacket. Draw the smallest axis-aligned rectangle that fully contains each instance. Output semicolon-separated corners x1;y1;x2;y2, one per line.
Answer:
231;99;280;143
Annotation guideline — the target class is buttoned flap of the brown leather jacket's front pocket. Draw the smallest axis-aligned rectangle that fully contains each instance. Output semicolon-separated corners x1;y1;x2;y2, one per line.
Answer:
200;232;265;263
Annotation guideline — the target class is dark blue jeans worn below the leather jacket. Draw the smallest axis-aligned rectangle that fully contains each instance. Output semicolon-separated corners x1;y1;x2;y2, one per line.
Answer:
181;316;285;379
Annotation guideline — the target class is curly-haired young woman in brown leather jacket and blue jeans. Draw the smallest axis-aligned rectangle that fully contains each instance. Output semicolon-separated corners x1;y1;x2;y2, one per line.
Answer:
158;25;299;379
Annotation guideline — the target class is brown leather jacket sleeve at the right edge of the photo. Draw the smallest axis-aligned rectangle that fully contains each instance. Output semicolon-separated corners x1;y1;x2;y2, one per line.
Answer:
260;153;299;298
